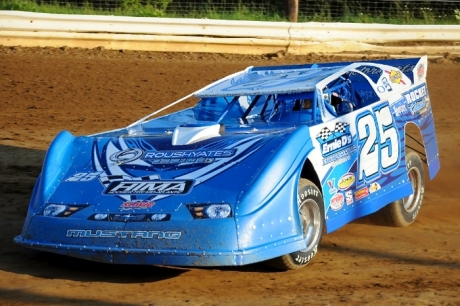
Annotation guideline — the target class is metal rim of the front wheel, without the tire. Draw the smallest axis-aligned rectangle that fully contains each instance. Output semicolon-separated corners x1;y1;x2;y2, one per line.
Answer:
299;199;321;252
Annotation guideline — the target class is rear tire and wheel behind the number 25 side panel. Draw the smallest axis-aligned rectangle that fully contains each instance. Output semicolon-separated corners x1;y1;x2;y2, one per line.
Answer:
381;150;425;227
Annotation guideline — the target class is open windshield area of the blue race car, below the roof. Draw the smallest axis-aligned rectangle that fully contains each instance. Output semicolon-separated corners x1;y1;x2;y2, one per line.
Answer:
137;92;321;134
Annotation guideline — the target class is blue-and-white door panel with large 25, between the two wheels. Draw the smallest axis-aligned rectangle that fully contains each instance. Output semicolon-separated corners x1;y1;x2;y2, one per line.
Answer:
311;102;412;233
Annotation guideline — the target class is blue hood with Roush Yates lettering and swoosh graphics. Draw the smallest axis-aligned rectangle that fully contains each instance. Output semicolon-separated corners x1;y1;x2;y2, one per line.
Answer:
41;127;308;213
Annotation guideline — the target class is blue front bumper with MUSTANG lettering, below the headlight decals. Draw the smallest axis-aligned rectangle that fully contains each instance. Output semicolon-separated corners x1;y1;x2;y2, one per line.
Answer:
14;215;305;266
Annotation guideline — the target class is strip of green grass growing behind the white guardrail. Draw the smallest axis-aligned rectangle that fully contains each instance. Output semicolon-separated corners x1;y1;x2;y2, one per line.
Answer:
0;0;460;25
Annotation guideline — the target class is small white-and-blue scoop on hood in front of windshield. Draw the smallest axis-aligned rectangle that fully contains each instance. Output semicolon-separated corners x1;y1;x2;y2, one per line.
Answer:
172;123;225;146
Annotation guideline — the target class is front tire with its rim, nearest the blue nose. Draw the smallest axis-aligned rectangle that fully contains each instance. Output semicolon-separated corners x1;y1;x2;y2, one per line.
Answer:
268;178;325;270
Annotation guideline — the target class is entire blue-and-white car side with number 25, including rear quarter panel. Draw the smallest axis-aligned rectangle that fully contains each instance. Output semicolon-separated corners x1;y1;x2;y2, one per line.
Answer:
310;57;440;232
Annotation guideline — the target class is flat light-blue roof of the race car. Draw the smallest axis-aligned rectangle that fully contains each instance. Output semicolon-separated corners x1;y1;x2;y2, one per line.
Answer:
195;65;344;98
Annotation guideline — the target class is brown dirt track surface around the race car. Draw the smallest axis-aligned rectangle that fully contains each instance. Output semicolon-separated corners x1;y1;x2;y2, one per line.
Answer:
0;48;460;306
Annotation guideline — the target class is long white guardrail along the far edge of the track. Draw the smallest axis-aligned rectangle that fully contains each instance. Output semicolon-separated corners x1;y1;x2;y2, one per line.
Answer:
0;11;460;54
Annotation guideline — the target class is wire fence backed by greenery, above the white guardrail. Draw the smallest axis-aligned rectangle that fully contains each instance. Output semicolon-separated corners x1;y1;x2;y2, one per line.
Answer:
0;0;460;24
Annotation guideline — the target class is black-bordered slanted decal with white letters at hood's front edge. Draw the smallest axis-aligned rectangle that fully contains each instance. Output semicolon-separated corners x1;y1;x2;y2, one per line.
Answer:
104;180;193;194
